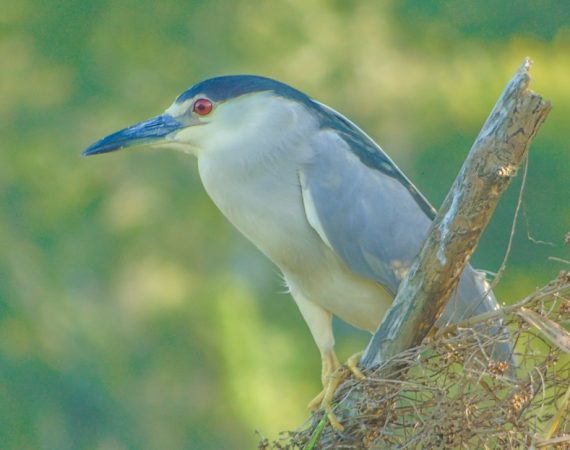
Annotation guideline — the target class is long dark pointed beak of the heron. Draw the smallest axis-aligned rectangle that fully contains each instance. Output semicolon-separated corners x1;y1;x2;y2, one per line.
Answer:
82;114;183;156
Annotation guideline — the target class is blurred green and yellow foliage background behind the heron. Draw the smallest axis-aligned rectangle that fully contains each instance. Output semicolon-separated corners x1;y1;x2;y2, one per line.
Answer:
0;0;570;450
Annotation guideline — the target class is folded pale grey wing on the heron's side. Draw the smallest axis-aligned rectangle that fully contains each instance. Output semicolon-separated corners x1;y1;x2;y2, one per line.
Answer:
301;130;431;295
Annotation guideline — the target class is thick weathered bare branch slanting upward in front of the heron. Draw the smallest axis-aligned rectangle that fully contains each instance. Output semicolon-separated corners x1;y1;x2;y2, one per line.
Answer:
361;58;551;368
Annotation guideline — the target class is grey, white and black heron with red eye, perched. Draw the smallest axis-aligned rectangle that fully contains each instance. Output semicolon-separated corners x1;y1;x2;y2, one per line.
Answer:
83;75;512;429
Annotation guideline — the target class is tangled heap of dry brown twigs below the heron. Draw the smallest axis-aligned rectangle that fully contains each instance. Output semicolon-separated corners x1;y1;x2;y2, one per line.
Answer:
259;272;570;450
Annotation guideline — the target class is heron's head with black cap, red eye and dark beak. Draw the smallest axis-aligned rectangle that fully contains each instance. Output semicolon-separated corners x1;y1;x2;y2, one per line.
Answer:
83;75;313;156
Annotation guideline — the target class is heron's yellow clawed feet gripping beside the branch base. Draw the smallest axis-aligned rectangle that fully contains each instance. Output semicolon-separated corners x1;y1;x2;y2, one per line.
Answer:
308;352;366;431
